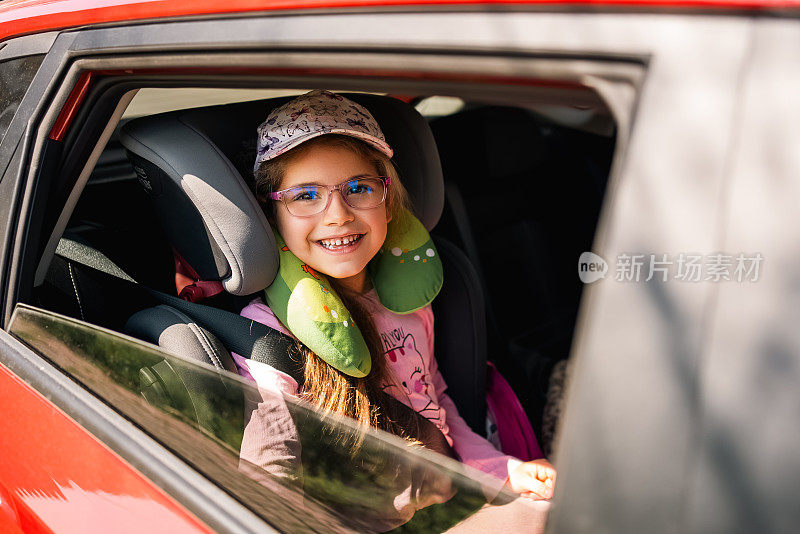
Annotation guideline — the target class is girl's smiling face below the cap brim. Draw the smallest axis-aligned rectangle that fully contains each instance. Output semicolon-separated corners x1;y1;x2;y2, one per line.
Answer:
274;144;390;292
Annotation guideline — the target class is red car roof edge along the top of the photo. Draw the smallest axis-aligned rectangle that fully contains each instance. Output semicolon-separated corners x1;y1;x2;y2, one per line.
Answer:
0;0;800;41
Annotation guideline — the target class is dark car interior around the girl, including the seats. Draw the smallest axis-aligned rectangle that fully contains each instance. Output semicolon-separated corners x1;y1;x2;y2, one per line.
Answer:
25;86;615;458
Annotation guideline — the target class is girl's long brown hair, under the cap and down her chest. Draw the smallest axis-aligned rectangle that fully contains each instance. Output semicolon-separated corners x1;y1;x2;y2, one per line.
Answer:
254;134;419;450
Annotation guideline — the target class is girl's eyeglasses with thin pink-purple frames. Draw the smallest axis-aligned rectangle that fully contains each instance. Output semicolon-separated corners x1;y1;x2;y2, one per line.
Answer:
269;176;391;217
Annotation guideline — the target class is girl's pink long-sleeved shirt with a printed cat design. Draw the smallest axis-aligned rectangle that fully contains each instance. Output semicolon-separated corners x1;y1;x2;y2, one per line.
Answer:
233;291;520;486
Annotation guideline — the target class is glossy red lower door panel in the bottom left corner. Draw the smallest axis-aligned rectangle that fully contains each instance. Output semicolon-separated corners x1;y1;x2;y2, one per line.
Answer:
0;366;210;532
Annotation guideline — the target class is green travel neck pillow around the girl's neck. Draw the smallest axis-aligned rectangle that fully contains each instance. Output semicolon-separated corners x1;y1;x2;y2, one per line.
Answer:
264;210;443;378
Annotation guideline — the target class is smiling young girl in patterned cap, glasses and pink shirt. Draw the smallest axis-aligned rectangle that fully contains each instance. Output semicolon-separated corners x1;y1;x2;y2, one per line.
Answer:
234;90;556;528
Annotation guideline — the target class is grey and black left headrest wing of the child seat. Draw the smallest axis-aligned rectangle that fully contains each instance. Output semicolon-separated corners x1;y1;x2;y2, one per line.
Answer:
120;113;278;295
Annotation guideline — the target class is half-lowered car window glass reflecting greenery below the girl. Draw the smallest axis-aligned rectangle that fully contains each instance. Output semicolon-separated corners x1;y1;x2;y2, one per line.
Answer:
9;305;544;532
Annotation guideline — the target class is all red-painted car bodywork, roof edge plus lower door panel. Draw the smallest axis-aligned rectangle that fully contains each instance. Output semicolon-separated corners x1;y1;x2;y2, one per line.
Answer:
0;0;800;533
